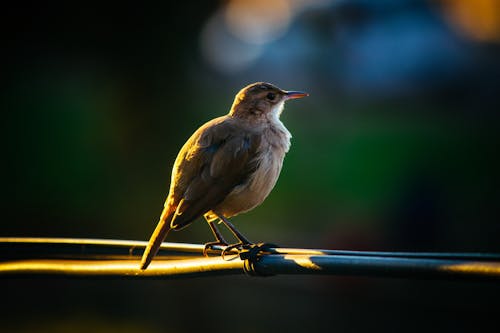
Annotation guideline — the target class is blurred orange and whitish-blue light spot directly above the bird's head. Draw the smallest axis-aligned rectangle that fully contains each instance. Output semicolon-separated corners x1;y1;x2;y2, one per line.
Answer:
200;0;332;74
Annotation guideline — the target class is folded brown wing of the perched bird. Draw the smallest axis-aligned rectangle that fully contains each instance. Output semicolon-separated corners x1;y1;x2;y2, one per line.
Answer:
168;118;260;229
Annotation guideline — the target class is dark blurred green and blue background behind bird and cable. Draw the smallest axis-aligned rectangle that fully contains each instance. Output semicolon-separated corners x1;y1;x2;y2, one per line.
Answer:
0;0;500;333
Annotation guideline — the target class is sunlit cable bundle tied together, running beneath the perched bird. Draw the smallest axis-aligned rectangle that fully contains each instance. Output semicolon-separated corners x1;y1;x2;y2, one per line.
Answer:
0;238;500;281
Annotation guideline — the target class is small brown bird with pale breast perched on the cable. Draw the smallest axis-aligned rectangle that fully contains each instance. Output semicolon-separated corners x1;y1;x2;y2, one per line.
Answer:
141;82;308;269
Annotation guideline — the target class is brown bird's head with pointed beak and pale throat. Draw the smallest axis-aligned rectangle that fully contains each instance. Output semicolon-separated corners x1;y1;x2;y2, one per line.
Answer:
229;82;309;120
